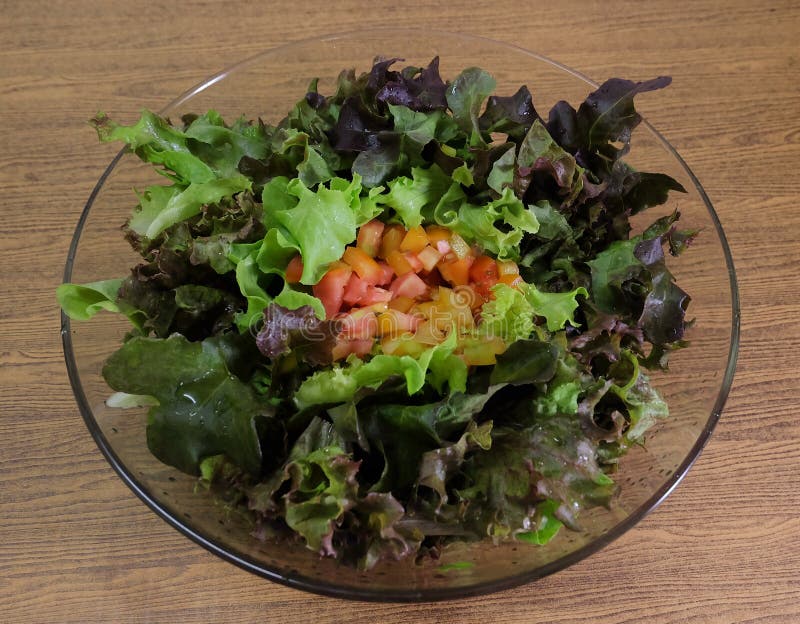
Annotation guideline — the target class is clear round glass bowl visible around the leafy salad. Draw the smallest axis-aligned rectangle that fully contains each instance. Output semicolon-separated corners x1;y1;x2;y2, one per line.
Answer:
62;29;739;601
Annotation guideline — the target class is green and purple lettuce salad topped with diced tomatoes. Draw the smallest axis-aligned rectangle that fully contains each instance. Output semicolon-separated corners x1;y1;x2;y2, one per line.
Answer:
58;58;697;568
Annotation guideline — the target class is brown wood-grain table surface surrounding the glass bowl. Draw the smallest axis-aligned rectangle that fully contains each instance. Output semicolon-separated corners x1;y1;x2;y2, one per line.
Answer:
0;0;800;624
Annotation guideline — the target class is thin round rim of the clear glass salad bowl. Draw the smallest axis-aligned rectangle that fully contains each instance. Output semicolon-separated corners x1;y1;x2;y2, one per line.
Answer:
61;28;740;602
